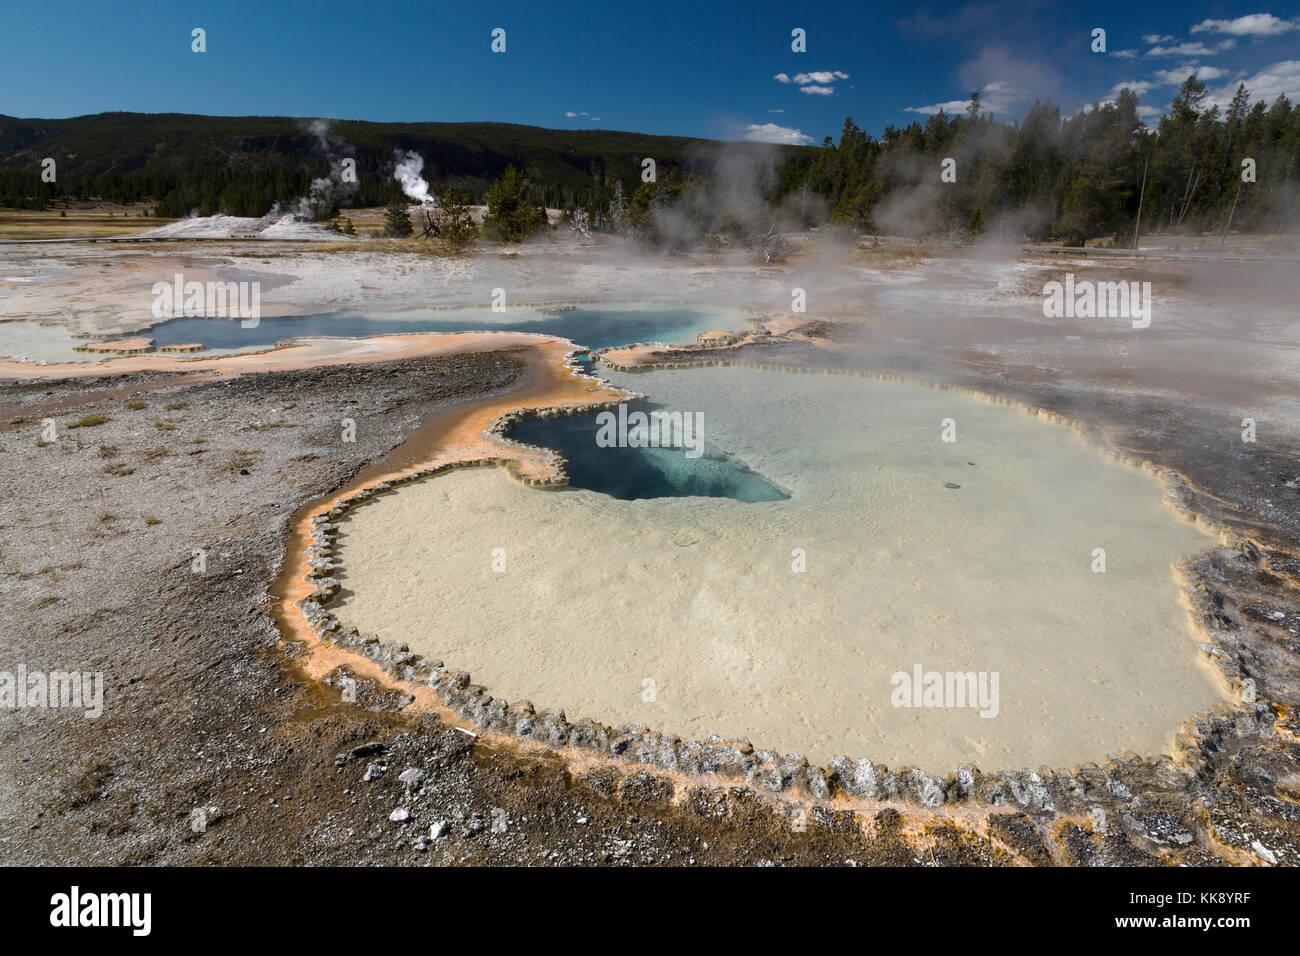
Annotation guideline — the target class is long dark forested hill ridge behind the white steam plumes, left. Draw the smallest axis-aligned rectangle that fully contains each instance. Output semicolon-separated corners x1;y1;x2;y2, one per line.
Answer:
0;113;759;216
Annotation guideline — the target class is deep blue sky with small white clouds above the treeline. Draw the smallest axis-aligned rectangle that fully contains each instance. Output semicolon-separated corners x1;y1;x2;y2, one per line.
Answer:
0;0;1300;143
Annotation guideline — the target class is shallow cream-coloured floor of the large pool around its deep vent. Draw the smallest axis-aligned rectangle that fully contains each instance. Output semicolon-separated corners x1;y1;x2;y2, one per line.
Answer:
335;368;1227;773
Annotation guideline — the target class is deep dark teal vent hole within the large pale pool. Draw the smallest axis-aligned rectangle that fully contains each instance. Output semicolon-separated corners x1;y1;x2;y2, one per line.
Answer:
510;405;790;502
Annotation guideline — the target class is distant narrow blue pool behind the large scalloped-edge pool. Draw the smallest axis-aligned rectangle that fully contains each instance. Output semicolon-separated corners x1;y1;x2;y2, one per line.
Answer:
140;307;736;350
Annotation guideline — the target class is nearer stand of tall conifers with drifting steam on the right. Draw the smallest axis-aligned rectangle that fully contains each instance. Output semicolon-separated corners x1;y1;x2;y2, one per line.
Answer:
764;78;1300;238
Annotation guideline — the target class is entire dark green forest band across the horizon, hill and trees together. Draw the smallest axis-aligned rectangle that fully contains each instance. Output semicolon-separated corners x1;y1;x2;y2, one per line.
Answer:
0;77;1300;241
